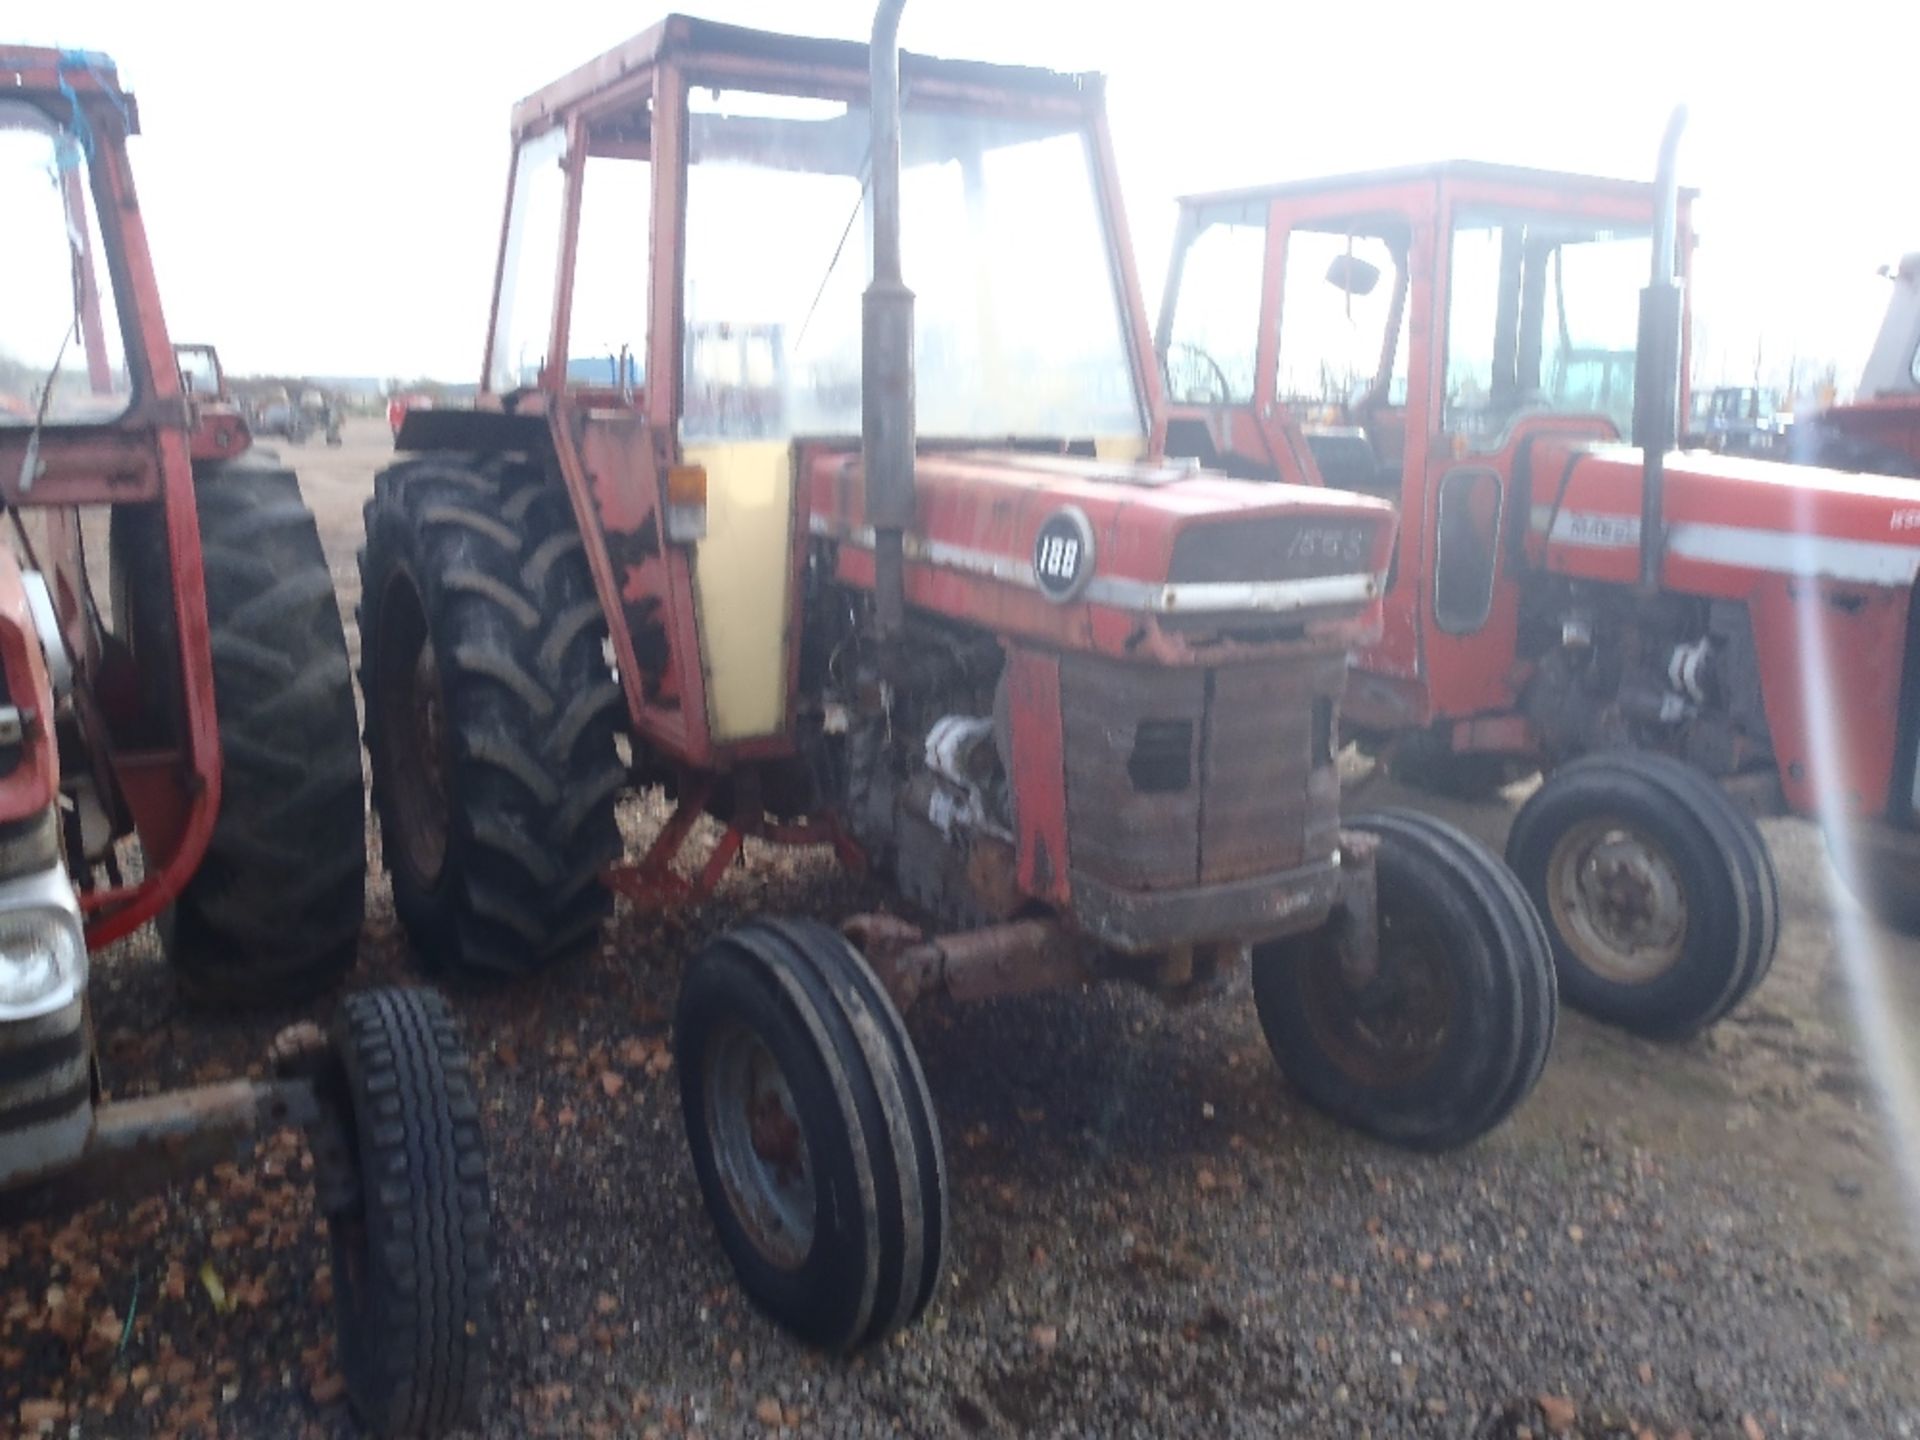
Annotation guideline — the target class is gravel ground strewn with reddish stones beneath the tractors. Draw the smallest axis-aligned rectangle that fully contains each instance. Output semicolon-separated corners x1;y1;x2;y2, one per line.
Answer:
0;426;1920;1440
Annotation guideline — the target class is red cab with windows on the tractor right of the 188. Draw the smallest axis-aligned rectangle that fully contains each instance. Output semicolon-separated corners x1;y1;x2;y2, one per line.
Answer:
1156;161;1692;728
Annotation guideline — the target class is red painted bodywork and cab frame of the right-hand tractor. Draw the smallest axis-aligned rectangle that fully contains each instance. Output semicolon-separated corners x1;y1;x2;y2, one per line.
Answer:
1169;163;1920;816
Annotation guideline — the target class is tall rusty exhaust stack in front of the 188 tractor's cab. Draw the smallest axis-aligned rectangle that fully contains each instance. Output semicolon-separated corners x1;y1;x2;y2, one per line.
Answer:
860;0;914;643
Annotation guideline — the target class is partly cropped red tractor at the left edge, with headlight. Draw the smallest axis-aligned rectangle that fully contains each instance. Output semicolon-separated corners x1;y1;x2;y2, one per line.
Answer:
0;46;492;1434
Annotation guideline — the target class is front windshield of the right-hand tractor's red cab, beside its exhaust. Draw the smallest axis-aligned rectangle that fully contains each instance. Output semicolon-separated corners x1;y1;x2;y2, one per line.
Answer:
1444;211;1653;438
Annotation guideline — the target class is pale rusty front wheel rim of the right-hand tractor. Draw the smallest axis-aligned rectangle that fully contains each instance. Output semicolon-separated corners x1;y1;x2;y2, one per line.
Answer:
1548;816;1688;985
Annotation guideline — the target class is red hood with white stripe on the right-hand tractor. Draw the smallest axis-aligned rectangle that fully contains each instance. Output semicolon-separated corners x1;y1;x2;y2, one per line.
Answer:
1517;440;1920;597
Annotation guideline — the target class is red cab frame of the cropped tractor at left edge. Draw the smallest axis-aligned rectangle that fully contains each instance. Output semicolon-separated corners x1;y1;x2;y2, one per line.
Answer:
0;46;221;947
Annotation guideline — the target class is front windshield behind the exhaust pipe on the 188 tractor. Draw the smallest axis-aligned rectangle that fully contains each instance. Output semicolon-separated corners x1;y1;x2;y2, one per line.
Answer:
682;90;1144;442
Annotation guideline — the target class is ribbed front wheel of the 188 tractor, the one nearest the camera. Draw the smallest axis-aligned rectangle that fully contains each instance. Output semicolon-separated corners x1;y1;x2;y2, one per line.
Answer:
674;920;947;1352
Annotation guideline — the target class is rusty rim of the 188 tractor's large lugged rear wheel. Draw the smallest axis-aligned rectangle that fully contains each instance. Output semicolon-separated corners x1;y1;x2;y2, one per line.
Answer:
374;576;447;889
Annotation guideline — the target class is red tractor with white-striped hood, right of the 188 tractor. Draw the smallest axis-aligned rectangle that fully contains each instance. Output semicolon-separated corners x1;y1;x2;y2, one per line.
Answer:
1156;115;1920;1037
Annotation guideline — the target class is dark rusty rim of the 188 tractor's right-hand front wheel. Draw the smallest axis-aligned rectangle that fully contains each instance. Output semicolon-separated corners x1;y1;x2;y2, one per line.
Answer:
1302;899;1457;1087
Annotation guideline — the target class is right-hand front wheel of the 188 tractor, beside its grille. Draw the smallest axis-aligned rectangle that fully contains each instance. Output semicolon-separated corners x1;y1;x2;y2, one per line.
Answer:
1254;810;1557;1150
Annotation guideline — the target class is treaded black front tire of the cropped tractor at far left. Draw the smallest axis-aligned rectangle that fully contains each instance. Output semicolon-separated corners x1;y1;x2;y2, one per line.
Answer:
324;989;493;1436
